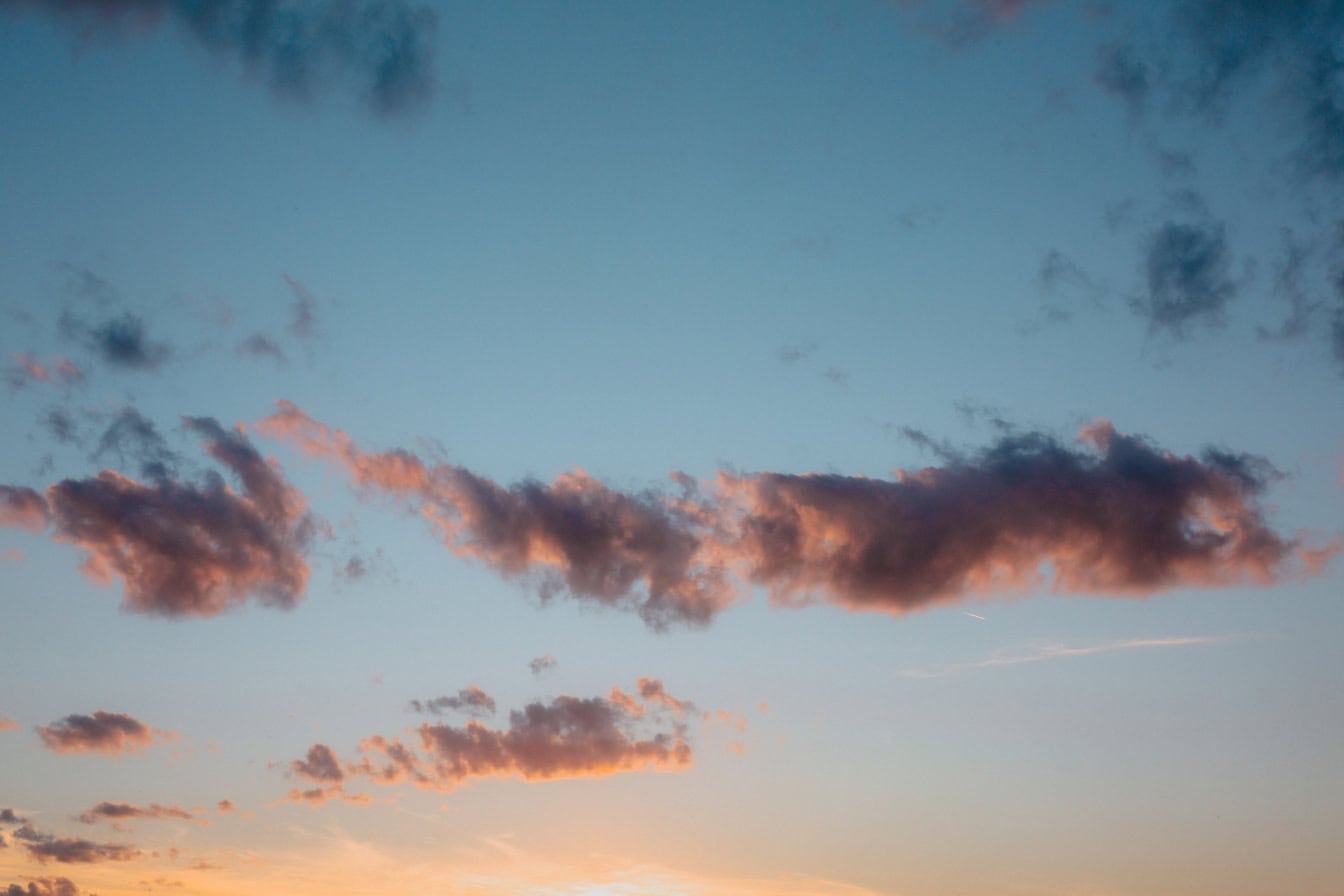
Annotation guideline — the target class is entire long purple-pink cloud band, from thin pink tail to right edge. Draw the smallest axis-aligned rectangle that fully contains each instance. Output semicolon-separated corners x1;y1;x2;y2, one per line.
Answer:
257;402;1340;626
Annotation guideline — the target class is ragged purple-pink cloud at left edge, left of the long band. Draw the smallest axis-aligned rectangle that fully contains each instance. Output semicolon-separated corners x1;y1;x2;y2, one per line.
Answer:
0;415;316;617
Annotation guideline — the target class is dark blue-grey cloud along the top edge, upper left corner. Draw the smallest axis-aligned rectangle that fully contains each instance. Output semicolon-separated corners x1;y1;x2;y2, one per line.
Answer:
0;0;437;117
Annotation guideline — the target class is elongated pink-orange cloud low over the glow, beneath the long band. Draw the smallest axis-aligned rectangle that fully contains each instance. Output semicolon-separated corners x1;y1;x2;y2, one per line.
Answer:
286;678;692;805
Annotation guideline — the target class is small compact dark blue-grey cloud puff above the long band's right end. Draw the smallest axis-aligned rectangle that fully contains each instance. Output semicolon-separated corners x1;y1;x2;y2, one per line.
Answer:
1130;220;1236;337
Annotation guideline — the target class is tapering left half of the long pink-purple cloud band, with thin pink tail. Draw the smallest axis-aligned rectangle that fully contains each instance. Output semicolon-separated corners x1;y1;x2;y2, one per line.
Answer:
257;402;732;627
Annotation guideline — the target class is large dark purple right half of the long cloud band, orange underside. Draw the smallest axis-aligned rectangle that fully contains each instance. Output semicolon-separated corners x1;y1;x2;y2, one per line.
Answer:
720;422;1333;614
